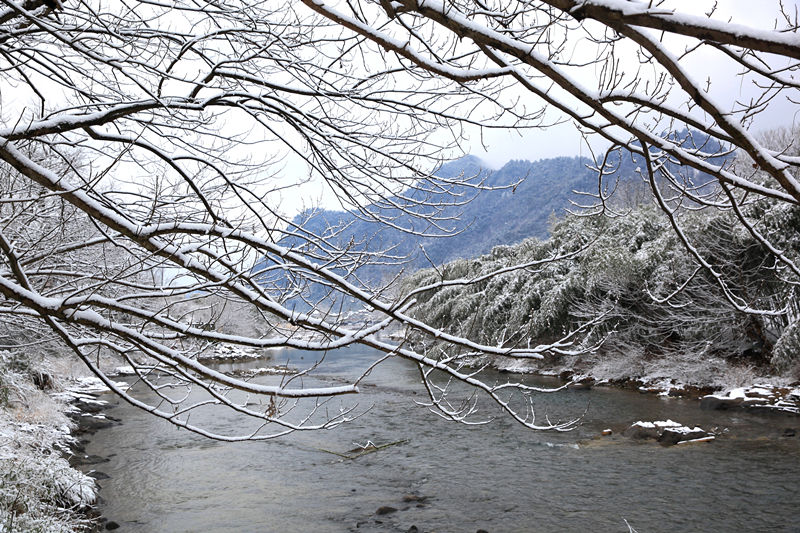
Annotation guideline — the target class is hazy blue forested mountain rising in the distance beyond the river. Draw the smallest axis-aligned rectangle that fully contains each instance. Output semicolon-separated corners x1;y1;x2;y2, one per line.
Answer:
272;152;652;309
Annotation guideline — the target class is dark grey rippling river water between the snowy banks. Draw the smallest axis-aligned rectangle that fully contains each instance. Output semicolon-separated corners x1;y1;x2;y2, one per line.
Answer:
87;350;800;533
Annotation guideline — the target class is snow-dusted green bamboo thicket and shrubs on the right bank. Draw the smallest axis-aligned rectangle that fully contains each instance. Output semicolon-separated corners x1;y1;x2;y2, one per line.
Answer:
405;197;800;384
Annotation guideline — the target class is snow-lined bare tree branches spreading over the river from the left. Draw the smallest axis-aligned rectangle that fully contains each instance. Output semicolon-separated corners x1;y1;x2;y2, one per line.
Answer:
0;0;580;439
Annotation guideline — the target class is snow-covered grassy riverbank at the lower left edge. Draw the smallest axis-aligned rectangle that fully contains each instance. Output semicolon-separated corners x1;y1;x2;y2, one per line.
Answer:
0;354;98;532
